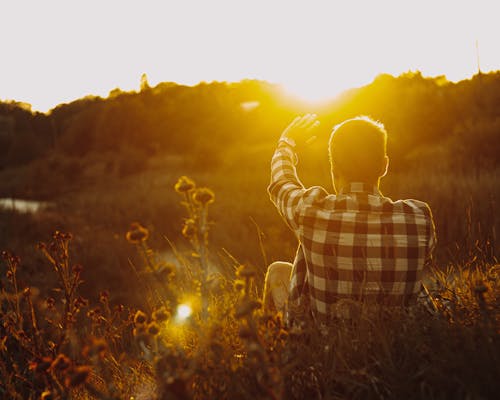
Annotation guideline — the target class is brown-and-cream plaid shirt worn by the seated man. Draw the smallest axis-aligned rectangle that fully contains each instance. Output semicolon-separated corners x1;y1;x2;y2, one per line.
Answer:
268;144;435;322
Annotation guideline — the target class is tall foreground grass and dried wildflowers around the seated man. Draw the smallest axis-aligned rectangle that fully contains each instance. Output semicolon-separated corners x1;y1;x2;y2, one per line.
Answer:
0;179;500;399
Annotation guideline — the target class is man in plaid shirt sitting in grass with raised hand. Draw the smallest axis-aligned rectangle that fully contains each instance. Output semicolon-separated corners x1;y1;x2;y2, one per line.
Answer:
264;115;435;323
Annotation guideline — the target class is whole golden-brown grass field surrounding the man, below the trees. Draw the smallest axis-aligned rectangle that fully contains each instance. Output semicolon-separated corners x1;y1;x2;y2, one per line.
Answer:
0;149;500;399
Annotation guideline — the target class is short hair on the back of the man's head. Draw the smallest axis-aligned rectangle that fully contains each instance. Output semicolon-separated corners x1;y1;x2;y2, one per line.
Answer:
329;116;387;182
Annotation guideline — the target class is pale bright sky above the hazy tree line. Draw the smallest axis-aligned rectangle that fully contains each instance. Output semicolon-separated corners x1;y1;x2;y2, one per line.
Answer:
0;0;500;111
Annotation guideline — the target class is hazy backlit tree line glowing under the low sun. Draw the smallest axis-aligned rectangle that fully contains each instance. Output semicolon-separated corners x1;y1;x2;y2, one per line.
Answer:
0;71;500;169
